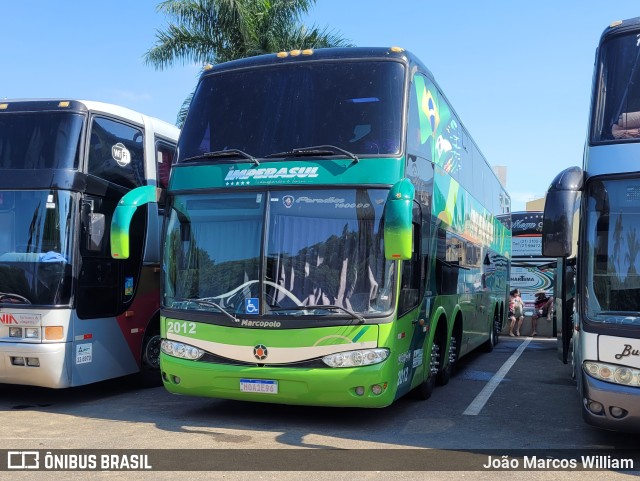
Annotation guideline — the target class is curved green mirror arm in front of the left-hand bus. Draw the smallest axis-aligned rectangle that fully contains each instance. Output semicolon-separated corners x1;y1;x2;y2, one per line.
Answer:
111;185;158;259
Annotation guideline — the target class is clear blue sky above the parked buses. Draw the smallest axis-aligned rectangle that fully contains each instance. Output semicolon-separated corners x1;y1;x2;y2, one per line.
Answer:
0;0;640;211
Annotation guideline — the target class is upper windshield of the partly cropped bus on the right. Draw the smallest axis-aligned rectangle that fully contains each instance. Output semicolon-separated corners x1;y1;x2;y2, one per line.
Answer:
591;33;640;144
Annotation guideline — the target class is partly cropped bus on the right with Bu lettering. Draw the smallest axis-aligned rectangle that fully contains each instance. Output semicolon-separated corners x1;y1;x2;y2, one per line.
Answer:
543;18;640;431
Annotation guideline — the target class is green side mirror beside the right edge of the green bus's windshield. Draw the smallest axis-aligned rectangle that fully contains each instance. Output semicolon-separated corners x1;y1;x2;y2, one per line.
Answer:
384;179;415;260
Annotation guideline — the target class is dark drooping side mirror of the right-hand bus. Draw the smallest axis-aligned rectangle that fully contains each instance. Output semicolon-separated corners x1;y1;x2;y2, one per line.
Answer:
542;167;584;258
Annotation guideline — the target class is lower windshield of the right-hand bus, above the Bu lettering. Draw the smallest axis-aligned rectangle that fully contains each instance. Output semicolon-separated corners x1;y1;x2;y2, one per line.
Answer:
585;179;640;327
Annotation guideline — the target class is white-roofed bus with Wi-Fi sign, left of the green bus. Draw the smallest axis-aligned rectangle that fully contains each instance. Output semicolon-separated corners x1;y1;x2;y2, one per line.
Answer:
0;99;179;388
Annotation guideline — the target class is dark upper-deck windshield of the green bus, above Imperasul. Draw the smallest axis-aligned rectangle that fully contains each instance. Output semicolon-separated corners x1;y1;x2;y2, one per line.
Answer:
179;60;405;161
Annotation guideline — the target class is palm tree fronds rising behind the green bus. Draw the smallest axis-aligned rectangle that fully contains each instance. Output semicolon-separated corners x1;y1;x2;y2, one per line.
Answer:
144;0;351;127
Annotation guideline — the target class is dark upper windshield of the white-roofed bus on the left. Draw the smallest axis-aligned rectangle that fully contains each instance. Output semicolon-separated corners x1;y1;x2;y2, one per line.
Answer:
0;112;84;169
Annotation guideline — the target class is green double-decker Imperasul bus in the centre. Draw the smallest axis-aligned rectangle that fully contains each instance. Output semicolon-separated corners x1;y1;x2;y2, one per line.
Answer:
112;48;511;407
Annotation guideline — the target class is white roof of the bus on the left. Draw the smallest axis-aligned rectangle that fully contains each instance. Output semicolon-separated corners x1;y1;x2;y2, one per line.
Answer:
0;98;180;139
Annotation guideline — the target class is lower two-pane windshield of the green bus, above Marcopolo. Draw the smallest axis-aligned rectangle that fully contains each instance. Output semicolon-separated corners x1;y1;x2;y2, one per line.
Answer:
164;189;393;317
